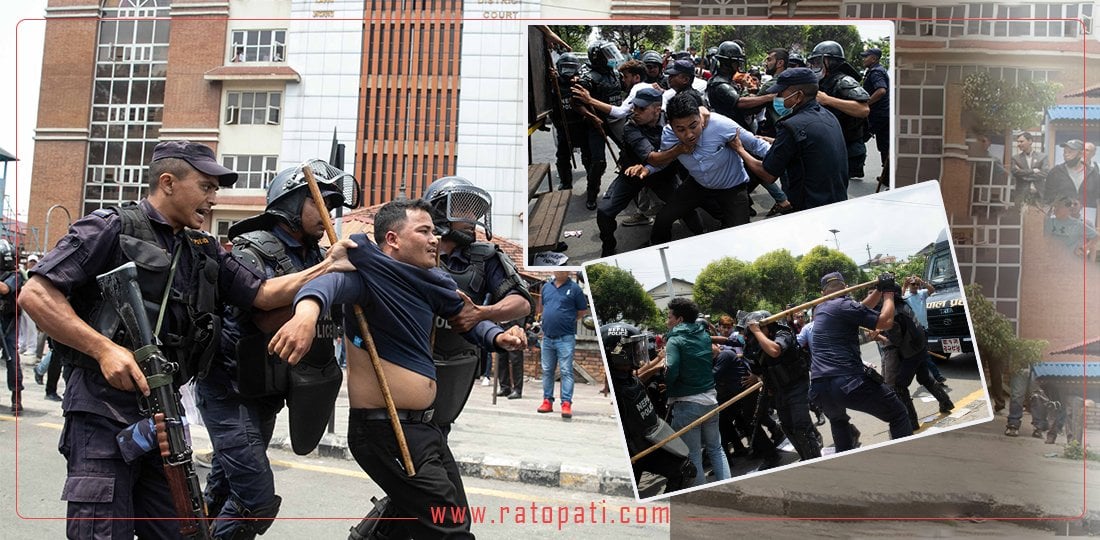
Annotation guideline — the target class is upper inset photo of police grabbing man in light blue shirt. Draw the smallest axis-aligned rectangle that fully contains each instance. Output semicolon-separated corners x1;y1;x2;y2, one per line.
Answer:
527;22;893;266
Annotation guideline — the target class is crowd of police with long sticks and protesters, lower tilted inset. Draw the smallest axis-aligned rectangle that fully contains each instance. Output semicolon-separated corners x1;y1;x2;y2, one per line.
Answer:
601;272;955;493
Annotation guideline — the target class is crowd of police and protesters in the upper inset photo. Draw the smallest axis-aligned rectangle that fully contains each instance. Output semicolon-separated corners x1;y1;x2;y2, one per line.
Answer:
549;35;890;256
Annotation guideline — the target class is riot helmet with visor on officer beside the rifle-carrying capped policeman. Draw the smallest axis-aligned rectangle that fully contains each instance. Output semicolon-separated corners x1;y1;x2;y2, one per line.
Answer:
264;161;355;231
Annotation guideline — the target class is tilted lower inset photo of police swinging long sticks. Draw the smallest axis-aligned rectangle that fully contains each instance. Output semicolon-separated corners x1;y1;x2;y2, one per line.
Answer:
584;181;993;500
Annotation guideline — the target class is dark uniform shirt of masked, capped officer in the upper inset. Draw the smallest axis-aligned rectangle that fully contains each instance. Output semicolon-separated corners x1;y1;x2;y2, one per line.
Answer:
763;97;848;210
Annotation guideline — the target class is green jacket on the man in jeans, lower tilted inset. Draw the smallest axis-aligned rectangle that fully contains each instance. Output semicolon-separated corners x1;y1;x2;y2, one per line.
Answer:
664;322;714;397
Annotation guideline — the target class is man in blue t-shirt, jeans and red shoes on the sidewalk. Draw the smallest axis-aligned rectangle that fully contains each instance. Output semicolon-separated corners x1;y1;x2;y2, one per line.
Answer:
538;272;589;418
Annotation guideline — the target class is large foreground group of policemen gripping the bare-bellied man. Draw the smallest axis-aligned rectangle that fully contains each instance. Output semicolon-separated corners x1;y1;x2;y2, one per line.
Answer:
10;141;534;539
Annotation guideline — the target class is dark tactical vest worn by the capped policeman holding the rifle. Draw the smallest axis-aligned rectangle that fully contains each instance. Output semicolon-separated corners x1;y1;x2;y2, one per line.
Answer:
56;203;221;385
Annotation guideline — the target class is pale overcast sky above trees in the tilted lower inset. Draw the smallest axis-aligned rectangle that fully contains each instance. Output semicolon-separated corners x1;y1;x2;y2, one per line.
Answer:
597;181;947;290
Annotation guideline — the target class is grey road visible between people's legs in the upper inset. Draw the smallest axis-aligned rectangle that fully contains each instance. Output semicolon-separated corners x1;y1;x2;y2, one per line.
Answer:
527;122;882;266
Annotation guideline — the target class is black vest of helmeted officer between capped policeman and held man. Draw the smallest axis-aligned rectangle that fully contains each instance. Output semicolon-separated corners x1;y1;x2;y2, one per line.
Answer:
233;231;340;366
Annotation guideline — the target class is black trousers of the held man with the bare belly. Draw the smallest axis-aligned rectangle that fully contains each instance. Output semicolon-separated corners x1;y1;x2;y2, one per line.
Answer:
348;409;474;539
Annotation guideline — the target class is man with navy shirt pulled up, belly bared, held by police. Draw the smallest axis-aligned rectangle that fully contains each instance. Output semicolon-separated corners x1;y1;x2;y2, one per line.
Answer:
268;199;527;538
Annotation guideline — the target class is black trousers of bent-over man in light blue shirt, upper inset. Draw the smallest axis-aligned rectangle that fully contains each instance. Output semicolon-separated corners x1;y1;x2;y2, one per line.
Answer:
650;178;752;244
